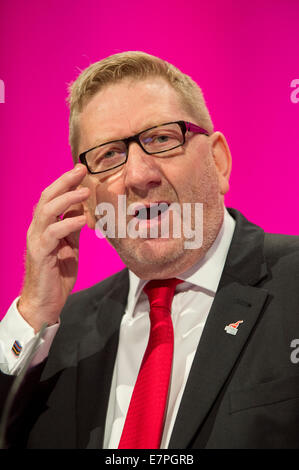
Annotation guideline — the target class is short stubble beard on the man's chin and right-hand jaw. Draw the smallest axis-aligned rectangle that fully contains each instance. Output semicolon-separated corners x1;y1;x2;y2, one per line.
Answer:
102;154;224;279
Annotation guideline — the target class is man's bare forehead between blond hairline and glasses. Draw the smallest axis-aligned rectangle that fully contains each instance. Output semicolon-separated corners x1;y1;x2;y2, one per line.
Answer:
78;78;188;151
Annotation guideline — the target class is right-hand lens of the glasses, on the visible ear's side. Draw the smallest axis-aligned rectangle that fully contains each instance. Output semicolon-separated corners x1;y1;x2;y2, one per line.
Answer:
140;123;184;153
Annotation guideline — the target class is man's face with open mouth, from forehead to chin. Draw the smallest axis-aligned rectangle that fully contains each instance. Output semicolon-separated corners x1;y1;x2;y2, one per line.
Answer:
78;77;230;279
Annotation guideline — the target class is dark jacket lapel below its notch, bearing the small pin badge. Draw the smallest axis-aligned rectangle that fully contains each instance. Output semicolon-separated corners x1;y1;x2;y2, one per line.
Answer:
169;283;267;448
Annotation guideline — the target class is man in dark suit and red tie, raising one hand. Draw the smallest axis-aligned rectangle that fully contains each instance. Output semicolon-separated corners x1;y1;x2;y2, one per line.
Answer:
1;52;299;448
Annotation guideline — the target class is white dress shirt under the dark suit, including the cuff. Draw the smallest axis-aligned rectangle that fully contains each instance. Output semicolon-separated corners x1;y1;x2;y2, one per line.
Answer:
0;210;235;449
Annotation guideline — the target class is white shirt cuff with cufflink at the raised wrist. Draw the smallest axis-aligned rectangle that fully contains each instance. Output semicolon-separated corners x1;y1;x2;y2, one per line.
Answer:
0;297;60;375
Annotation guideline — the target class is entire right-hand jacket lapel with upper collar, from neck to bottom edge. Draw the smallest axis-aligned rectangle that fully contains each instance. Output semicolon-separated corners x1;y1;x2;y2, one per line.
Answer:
169;210;268;449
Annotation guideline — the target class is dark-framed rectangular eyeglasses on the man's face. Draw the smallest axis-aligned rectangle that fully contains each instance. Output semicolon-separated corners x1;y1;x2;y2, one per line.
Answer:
79;121;209;174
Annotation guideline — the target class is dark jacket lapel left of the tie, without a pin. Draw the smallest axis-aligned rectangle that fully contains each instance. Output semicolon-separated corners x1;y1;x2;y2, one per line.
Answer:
76;270;129;449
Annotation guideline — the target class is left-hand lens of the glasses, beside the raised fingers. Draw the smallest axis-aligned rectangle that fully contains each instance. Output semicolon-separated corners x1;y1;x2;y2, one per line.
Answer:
85;141;127;173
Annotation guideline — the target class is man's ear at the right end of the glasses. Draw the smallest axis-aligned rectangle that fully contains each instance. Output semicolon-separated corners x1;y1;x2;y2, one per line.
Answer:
209;131;232;195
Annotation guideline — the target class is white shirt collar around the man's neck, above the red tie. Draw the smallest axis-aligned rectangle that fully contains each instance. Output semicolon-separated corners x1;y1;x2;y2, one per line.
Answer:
127;208;236;314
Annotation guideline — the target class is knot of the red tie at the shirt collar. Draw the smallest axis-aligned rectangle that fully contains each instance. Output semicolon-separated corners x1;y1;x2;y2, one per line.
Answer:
143;278;183;312
